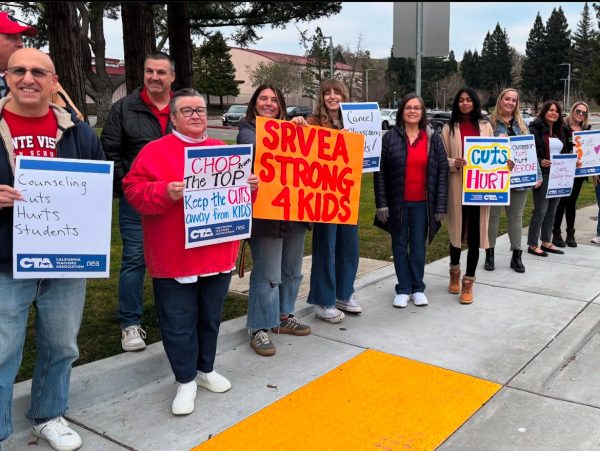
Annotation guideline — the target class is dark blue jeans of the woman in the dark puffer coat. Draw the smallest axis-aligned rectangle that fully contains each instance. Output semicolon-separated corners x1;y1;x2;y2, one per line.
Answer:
392;201;427;294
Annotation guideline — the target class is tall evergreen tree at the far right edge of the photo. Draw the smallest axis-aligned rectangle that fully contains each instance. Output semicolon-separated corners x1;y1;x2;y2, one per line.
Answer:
571;2;599;100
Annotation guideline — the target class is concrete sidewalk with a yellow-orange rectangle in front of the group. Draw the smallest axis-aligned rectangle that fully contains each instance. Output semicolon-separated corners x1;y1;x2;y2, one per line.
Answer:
2;206;600;451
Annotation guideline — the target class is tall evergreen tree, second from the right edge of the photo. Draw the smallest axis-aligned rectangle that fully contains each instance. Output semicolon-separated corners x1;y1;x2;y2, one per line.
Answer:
538;7;571;100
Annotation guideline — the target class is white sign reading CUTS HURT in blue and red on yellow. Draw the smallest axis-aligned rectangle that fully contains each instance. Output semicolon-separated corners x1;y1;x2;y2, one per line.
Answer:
463;136;510;205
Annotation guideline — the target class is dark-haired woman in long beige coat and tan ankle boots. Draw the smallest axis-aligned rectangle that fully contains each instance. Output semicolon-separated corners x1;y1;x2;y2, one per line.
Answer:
442;88;493;304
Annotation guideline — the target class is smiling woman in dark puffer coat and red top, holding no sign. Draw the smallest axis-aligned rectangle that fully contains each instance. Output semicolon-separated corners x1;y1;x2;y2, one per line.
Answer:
374;94;448;308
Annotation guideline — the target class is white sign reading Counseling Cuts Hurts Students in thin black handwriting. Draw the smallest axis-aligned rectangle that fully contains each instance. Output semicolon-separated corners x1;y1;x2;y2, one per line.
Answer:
13;157;114;279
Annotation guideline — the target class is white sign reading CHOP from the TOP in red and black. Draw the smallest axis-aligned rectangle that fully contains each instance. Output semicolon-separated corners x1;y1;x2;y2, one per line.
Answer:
183;144;252;249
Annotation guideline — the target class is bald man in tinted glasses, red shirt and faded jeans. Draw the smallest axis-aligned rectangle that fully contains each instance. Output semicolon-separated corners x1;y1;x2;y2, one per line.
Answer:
0;49;104;450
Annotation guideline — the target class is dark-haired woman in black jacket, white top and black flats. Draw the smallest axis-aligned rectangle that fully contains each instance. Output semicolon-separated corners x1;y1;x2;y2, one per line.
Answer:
527;100;567;257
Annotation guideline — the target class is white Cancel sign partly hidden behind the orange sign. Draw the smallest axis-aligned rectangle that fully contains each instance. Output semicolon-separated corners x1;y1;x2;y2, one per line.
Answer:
340;102;381;172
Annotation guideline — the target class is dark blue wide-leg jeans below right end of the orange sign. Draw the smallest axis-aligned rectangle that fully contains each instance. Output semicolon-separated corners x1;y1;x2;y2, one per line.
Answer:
308;223;358;307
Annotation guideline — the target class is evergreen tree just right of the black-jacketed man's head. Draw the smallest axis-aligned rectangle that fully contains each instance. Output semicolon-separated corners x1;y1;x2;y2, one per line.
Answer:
193;31;240;107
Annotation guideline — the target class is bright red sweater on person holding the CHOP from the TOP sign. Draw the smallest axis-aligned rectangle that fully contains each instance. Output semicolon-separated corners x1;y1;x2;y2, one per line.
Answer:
123;134;240;278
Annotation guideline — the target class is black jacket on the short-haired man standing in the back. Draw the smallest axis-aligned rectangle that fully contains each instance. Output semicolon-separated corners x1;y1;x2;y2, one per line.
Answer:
100;88;173;194
